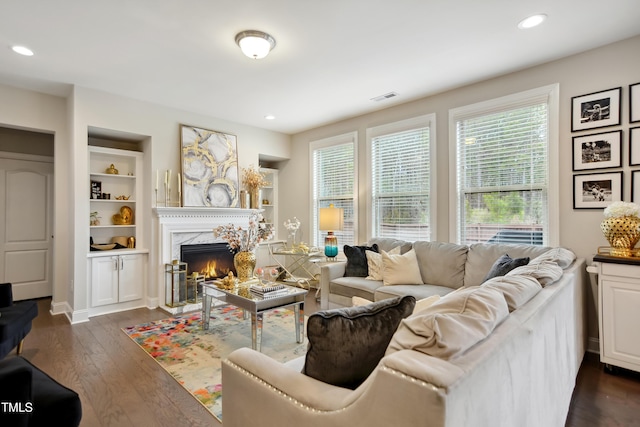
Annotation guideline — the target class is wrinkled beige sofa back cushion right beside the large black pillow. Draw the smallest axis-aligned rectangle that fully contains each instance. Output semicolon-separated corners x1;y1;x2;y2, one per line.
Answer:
385;286;509;359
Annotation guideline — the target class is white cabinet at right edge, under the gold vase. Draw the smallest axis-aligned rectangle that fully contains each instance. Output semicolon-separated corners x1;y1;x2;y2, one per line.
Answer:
594;255;640;372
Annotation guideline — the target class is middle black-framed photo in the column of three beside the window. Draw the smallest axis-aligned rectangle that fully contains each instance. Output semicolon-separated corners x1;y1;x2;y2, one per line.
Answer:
573;130;622;171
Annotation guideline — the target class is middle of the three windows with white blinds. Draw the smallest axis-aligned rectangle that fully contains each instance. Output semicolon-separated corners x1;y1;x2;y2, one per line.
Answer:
368;115;434;241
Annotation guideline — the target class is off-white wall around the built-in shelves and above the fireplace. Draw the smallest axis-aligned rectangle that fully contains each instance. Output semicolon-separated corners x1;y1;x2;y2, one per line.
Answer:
0;81;290;322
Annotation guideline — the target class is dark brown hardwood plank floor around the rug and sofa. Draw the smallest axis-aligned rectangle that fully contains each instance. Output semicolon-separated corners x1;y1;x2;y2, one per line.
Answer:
7;293;640;427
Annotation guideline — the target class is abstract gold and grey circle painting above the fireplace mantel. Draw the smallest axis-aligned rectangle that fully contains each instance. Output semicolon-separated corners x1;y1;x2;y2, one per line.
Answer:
180;125;240;208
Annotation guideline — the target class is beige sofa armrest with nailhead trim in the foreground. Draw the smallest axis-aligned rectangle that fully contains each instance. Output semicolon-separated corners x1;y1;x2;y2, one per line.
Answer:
222;348;446;427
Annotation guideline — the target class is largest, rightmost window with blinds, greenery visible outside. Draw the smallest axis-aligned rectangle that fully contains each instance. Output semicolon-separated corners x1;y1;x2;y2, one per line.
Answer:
450;86;558;245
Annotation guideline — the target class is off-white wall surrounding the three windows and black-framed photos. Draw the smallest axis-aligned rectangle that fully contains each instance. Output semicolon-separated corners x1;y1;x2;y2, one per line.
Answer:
279;37;640;346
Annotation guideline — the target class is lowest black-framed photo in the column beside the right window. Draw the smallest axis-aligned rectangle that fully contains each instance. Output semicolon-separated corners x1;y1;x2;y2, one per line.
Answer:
573;172;622;209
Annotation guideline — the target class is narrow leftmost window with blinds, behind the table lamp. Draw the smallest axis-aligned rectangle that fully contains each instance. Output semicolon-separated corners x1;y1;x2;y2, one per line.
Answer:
311;132;357;247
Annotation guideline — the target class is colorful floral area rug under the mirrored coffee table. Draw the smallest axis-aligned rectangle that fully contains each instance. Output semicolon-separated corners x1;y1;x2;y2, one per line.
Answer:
122;307;307;421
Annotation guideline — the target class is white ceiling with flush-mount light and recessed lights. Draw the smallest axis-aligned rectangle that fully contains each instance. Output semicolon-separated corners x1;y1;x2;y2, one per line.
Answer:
0;0;640;133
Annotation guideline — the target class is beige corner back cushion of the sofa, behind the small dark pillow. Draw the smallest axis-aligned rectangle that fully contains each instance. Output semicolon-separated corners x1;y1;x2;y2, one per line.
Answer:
464;243;550;286
